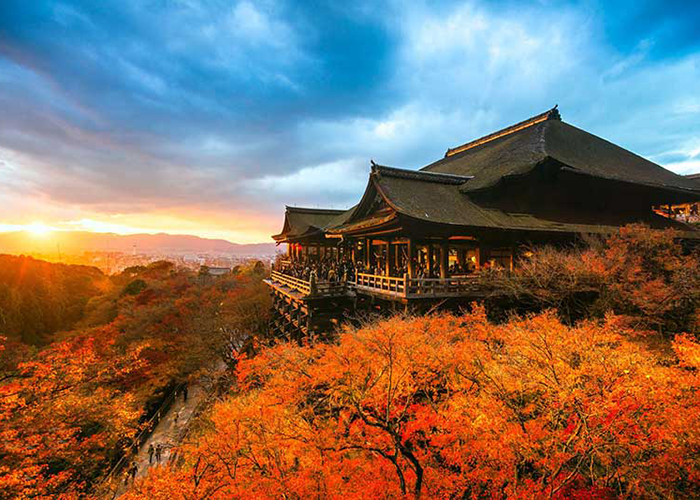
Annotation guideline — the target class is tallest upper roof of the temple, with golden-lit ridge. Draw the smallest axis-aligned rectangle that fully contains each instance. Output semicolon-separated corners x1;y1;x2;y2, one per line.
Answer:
422;108;700;193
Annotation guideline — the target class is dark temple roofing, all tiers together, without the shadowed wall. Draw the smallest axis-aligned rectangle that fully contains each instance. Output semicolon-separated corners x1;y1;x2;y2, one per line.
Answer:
274;107;700;241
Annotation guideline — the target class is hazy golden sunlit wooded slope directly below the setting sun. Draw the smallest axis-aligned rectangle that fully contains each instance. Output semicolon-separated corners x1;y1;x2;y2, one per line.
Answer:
0;255;112;345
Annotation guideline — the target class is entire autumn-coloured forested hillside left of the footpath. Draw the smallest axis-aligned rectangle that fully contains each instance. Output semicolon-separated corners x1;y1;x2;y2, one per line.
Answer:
0;258;269;498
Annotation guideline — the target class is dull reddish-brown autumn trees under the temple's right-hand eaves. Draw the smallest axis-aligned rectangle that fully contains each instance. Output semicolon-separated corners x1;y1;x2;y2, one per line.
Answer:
494;224;700;335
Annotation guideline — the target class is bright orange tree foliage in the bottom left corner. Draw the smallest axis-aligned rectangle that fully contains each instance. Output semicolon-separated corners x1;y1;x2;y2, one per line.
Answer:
0;328;145;498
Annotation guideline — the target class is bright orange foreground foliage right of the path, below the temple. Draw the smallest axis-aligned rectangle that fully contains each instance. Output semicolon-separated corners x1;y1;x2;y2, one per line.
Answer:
126;310;700;499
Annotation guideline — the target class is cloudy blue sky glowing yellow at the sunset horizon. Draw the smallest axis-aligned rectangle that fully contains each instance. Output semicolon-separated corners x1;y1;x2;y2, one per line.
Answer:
0;0;700;243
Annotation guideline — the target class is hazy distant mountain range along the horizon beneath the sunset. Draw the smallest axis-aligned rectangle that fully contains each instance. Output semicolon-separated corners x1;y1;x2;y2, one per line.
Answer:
0;231;278;256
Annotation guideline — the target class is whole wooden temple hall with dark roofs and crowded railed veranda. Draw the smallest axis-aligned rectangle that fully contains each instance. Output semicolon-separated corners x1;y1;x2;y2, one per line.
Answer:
267;106;700;334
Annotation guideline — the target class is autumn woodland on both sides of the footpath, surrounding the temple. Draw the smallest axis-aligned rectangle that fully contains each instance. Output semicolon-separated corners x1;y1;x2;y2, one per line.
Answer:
0;226;700;500
